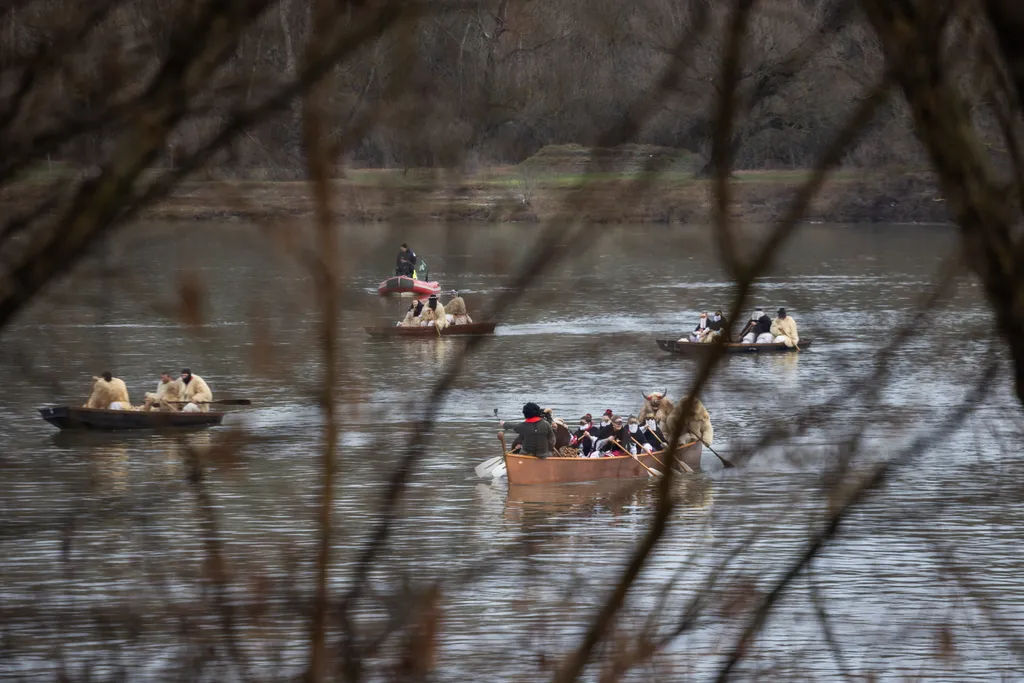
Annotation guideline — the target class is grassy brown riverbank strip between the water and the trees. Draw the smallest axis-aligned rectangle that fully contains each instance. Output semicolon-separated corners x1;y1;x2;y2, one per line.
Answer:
144;165;949;223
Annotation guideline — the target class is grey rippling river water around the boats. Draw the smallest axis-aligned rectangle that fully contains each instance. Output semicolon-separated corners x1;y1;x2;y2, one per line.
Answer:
0;223;1024;681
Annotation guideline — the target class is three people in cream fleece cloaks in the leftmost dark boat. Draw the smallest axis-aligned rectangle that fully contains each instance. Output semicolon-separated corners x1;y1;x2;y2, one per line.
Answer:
85;368;213;413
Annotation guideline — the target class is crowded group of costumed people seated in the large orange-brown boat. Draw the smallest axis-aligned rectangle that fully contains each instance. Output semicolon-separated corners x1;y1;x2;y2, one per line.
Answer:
501;392;714;459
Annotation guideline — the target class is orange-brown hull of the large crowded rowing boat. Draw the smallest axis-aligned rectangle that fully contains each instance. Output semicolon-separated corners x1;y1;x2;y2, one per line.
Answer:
505;441;702;485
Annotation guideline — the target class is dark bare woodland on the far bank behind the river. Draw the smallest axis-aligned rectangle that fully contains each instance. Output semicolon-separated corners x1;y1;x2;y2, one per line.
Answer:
0;0;991;176
